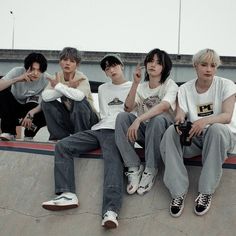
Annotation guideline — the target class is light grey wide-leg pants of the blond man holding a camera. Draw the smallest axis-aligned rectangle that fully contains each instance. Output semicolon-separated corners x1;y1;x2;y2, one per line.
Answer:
160;123;234;198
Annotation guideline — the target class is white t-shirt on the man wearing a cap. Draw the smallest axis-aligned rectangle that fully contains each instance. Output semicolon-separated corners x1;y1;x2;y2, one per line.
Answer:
92;81;132;130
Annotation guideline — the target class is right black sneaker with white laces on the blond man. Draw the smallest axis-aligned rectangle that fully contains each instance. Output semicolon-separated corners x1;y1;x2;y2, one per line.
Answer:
194;193;212;216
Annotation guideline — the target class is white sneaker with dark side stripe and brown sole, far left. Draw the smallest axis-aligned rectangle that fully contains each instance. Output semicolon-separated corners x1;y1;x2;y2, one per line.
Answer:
42;192;79;211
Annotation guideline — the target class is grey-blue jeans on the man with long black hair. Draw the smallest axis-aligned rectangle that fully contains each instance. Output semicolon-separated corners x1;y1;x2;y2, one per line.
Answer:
115;112;173;168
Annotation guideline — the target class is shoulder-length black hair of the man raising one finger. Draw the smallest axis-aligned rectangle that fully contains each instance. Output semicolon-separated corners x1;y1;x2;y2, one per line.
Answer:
144;48;172;84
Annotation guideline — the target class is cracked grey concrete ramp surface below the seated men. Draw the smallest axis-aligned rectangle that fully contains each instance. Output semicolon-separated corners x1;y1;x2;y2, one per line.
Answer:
0;151;236;236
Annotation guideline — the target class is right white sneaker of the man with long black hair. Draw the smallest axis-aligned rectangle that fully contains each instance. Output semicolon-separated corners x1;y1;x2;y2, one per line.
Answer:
137;169;158;195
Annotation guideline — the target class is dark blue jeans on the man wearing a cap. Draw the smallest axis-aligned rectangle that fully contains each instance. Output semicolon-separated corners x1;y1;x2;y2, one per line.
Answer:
54;129;123;214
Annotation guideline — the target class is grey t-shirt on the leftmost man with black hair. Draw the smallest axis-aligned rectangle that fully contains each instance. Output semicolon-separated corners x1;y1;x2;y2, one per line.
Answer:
2;67;49;104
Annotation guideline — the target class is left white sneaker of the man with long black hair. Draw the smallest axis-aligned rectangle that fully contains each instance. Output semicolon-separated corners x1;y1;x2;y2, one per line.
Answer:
125;165;143;194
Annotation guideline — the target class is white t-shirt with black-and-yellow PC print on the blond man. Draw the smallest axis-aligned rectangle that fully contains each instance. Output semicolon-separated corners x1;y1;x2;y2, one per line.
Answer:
178;76;236;134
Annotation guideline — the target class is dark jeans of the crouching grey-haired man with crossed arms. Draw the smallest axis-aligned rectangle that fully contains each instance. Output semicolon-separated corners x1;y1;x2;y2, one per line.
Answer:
41;98;98;140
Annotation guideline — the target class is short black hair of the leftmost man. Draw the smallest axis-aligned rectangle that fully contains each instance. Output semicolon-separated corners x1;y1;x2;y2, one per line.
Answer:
24;52;48;73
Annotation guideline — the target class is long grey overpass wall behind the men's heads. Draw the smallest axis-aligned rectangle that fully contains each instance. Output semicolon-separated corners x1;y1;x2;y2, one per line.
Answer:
0;49;236;82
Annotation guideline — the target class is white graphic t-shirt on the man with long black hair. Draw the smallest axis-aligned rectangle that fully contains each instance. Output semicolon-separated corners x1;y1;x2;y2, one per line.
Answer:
135;79;179;117
